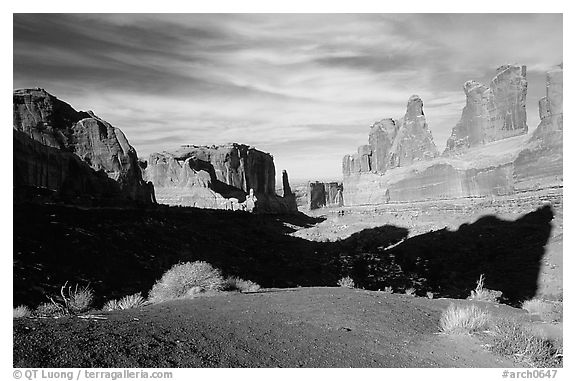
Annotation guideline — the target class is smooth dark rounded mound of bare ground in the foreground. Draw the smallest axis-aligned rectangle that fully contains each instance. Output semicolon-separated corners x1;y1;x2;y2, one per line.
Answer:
14;287;525;368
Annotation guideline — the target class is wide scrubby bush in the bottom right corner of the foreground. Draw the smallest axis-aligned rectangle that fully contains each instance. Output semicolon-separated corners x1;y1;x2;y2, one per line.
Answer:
491;319;563;368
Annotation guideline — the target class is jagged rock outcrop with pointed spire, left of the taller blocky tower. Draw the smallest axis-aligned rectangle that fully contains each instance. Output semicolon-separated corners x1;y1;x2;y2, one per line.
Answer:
342;95;438;176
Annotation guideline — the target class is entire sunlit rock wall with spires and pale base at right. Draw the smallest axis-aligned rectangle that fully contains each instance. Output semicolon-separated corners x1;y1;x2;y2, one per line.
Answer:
342;65;563;206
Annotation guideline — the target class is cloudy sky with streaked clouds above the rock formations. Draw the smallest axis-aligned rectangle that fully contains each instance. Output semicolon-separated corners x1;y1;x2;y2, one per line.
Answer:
14;14;563;179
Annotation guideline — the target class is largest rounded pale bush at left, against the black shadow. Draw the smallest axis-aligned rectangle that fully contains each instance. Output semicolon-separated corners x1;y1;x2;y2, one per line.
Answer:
148;261;224;303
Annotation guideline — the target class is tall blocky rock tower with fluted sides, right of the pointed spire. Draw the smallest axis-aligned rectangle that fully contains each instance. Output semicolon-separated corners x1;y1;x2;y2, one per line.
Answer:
444;65;528;154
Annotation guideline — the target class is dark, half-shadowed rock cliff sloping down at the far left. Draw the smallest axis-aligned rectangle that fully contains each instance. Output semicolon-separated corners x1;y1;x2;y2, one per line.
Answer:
13;89;154;203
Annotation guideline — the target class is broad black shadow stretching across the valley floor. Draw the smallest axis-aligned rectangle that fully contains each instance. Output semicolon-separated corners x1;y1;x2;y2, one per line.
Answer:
13;204;553;306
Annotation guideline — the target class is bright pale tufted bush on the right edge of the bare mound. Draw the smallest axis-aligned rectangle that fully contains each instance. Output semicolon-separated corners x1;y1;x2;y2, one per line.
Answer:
440;304;490;334
